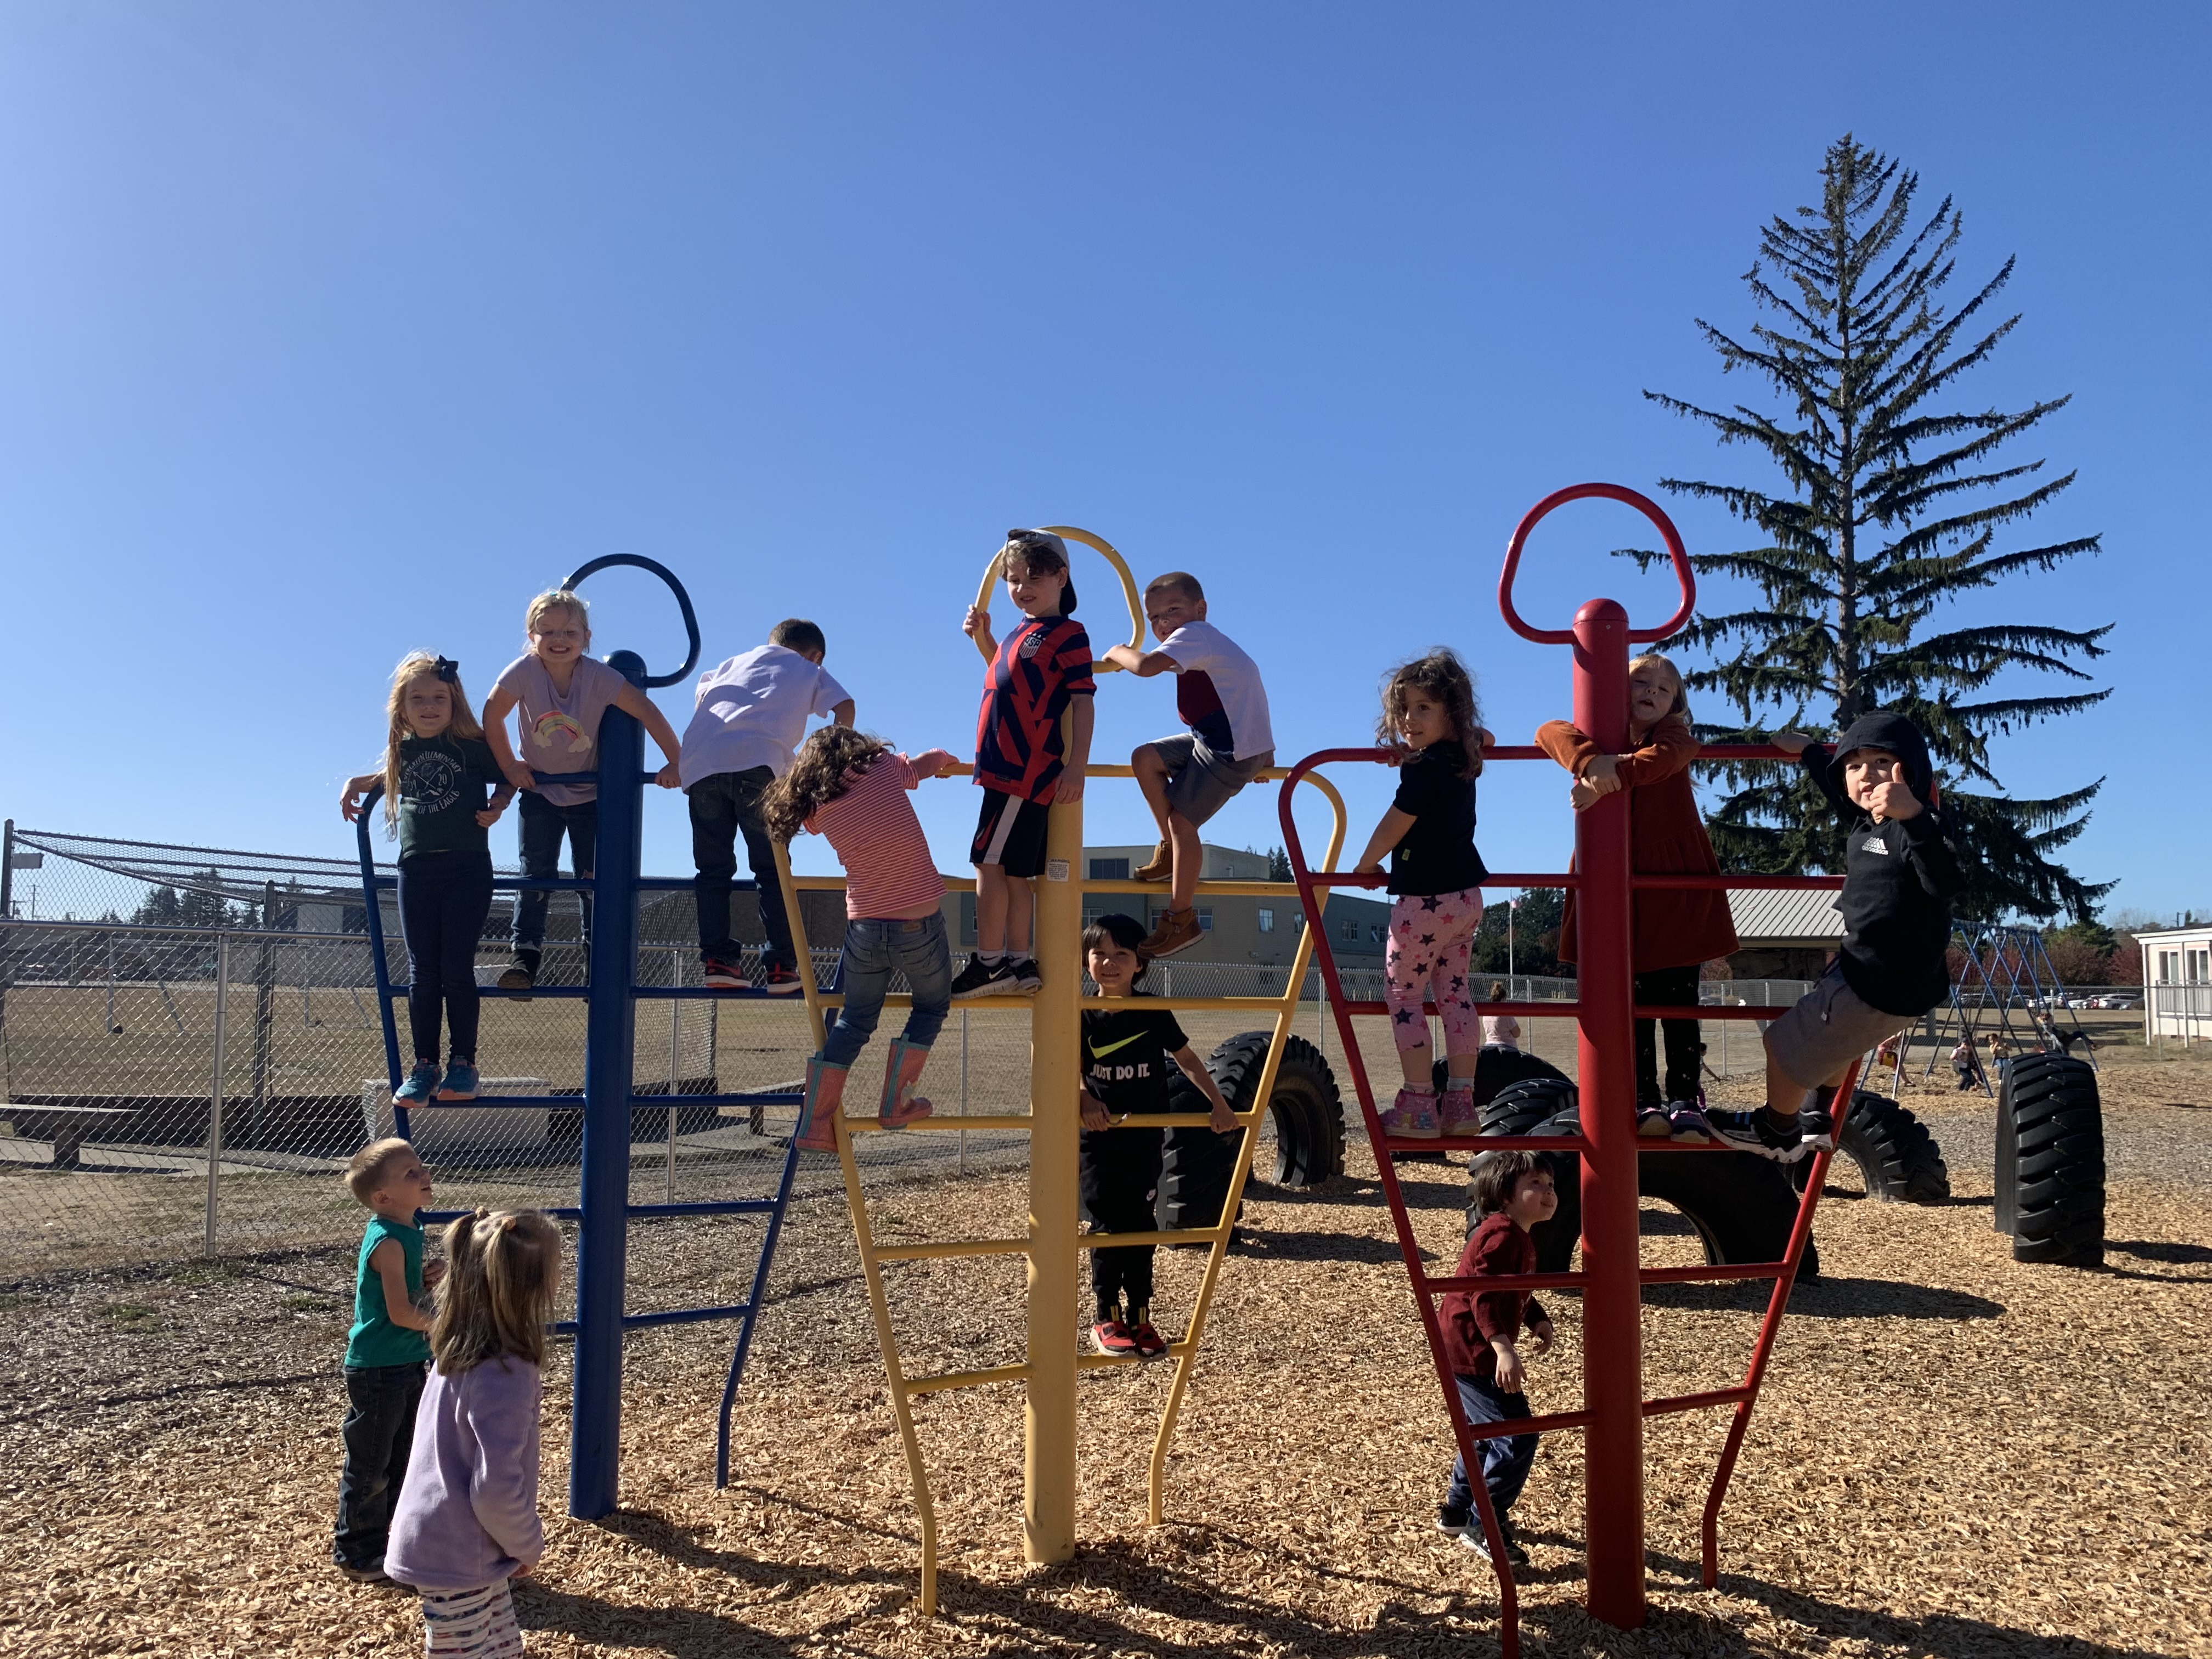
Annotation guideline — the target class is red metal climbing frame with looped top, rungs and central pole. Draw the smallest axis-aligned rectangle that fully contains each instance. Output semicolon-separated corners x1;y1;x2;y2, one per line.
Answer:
1281;484;1858;1659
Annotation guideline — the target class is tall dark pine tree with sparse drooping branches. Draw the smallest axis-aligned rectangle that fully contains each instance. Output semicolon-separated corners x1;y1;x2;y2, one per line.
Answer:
1633;135;2113;920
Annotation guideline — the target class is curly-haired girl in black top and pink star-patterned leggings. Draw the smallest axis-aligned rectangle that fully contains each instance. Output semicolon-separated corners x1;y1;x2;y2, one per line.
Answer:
1356;648;1491;1142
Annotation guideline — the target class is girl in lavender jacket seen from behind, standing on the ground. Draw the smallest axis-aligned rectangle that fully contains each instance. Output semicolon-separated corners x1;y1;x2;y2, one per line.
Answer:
385;1210;560;1659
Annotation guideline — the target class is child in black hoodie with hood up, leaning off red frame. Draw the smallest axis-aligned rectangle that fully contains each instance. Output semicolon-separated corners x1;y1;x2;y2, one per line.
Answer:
1708;714;1966;1164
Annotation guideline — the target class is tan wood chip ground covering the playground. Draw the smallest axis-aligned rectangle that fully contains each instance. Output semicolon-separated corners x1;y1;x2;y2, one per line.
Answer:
0;1062;2212;1659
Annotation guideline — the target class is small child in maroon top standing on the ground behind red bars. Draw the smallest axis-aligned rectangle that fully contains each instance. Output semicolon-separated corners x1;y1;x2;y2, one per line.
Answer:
1436;1150;1560;1566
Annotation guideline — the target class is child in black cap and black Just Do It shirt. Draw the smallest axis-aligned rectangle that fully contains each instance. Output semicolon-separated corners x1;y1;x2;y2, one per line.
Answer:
1080;916;1237;1361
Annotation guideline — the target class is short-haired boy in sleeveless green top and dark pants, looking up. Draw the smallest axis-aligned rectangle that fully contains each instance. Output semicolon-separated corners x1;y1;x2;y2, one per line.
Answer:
332;1139;444;1584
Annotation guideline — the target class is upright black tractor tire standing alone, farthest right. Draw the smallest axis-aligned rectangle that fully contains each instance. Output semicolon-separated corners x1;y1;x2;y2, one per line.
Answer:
1995;1053;2103;1267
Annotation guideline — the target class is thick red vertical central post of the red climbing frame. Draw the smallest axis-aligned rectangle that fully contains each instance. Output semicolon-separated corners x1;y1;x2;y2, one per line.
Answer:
1575;600;1644;1630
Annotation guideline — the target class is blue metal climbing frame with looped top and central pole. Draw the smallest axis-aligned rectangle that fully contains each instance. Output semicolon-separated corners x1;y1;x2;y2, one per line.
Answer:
356;553;803;1520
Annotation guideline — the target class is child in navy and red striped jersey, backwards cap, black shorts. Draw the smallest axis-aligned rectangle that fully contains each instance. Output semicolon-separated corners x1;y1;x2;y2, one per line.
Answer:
953;531;1093;1002
